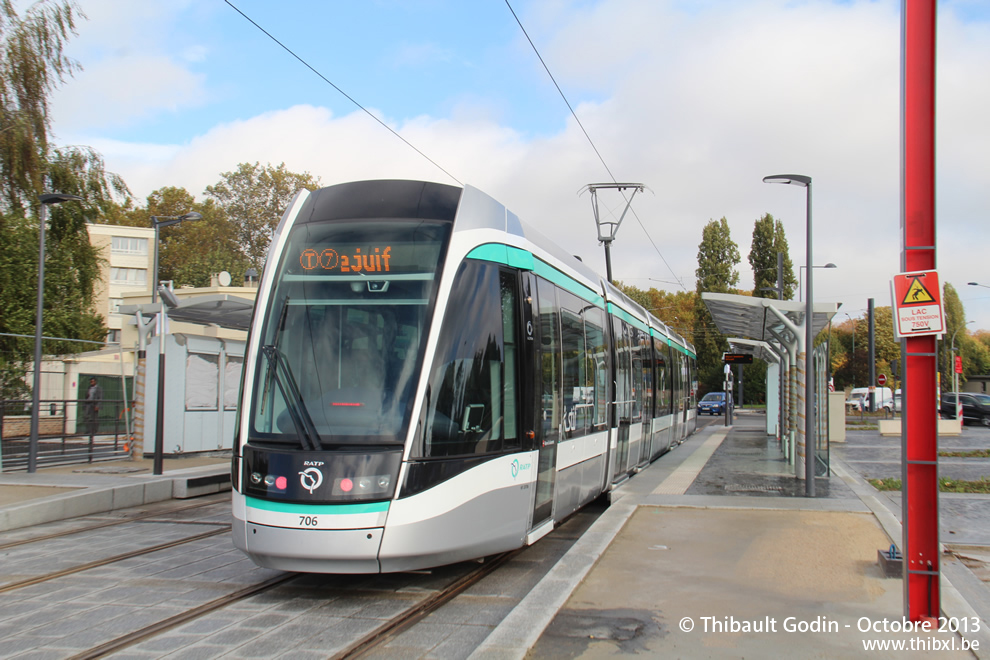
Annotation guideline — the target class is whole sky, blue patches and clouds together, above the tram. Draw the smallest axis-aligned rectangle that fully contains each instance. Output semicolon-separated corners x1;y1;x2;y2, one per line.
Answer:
53;0;990;329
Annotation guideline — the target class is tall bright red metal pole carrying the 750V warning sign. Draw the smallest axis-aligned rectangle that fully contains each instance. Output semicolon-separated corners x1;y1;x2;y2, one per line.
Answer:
901;0;941;621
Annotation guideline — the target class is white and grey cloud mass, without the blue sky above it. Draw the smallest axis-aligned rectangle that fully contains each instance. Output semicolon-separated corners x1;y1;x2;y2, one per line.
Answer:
58;0;990;328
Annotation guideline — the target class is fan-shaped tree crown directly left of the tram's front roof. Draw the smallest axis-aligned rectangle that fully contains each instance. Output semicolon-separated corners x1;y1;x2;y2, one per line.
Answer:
205;163;320;271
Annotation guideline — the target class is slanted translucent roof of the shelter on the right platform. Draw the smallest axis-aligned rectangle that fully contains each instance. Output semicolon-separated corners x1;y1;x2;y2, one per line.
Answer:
701;293;841;342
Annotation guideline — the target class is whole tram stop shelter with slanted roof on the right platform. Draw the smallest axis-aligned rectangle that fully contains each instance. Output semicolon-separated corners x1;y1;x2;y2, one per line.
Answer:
701;293;839;479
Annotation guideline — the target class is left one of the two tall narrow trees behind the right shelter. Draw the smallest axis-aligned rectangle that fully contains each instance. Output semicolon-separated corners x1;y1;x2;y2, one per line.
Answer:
694;218;740;390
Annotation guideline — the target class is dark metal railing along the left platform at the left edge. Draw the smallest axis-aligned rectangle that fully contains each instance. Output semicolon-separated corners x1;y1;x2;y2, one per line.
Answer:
0;399;132;472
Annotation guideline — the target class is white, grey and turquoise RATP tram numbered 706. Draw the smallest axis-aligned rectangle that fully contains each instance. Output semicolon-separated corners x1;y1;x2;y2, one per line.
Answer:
232;180;697;573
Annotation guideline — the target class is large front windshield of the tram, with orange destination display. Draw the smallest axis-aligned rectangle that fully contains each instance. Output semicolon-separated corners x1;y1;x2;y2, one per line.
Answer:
251;219;450;449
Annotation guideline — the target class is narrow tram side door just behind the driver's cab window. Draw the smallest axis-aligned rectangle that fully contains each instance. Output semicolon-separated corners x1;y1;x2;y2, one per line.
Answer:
532;278;563;527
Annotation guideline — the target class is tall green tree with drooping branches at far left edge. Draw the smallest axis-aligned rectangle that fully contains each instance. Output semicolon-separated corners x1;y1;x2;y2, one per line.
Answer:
0;0;128;397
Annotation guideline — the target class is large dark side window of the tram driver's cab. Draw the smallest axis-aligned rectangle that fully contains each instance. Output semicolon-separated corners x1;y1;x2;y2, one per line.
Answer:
416;260;519;458
